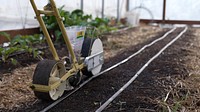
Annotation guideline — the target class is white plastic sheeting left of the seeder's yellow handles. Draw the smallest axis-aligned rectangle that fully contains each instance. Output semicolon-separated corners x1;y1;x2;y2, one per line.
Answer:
0;0;36;30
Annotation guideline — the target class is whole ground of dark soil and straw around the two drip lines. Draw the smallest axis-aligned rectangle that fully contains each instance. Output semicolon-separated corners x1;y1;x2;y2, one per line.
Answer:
0;26;200;112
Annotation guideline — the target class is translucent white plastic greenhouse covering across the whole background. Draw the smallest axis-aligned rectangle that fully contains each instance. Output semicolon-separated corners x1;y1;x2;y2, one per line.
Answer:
0;0;200;31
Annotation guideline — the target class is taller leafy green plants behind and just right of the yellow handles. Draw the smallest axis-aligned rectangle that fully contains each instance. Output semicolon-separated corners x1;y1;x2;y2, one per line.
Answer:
43;6;116;43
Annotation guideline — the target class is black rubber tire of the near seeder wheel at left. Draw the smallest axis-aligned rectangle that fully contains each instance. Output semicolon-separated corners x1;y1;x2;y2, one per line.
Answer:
32;60;57;101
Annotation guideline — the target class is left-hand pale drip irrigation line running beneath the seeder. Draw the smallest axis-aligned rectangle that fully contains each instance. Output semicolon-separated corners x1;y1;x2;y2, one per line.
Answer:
40;27;176;112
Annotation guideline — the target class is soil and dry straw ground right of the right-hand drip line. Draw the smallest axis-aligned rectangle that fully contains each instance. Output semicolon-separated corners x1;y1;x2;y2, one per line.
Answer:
98;29;200;112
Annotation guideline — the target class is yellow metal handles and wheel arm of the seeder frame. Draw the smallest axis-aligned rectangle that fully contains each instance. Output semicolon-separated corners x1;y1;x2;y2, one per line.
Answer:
30;0;84;92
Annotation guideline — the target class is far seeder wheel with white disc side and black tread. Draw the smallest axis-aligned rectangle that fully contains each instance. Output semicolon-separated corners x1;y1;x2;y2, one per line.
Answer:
81;38;103;76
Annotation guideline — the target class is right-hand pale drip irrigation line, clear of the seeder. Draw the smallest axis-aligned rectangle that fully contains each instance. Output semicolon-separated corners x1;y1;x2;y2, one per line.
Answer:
95;27;188;112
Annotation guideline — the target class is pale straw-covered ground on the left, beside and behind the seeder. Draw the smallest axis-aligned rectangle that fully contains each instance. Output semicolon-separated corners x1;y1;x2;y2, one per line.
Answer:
0;26;163;111
